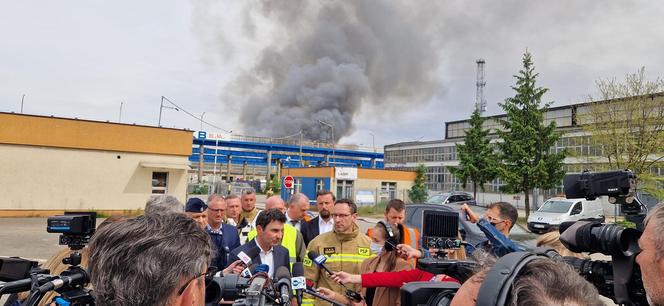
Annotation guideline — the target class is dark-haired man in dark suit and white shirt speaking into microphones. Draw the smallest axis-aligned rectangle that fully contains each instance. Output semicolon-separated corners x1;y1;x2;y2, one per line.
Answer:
228;209;290;277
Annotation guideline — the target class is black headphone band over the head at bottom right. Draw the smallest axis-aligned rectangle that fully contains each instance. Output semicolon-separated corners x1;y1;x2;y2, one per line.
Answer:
477;248;560;306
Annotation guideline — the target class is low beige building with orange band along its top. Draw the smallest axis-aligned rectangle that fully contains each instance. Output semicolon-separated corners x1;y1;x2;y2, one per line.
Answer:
0;113;192;216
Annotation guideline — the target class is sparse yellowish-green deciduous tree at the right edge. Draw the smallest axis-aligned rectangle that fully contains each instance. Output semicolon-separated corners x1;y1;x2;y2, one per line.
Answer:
578;67;664;200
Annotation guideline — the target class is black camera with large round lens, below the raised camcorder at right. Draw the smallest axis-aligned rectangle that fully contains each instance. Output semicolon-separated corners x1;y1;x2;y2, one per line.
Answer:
560;221;648;305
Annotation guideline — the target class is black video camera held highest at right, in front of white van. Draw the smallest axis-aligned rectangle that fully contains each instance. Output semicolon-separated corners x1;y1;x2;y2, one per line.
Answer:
563;170;648;231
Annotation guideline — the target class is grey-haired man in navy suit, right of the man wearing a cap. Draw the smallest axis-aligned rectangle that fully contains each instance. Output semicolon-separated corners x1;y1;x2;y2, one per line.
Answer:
205;194;240;269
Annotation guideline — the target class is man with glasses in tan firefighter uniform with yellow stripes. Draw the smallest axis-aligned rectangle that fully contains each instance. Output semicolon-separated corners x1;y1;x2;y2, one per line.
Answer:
302;199;374;306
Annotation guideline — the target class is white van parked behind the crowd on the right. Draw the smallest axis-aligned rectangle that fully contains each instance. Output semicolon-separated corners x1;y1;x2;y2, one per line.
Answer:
528;198;604;233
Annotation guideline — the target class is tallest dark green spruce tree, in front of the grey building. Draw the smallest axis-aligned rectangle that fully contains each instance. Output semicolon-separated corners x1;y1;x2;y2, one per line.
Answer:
496;52;566;217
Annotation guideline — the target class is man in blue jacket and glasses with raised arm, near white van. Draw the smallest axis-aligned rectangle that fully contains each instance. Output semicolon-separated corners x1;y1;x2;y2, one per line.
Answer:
461;202;522;257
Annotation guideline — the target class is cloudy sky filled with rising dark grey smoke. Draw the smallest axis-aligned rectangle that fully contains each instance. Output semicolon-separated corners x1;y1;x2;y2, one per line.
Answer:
0;0;664;149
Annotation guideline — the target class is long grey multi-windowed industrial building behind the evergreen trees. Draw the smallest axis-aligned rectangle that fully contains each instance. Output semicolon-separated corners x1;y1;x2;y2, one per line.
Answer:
384;93;664;207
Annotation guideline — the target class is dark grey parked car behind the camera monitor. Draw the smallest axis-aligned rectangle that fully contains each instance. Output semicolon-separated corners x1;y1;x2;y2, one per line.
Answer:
404;203;486;245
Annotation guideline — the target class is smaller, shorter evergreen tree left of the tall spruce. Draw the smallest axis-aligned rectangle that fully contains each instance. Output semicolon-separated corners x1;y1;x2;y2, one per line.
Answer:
450;108;498;199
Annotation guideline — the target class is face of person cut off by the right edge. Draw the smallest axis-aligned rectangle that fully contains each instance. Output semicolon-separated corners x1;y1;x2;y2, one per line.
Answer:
636;202;664;305
